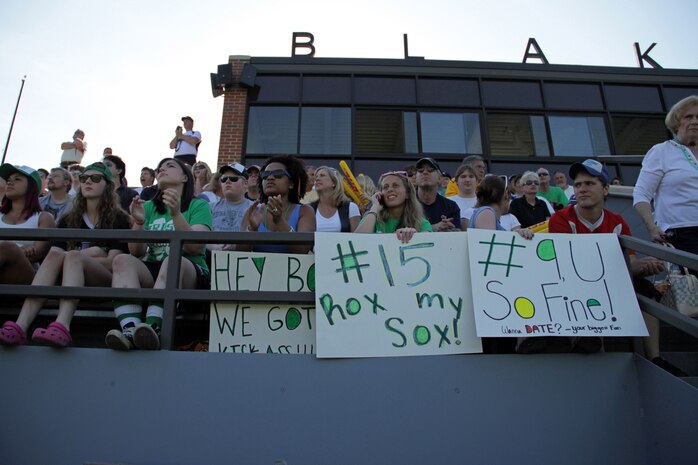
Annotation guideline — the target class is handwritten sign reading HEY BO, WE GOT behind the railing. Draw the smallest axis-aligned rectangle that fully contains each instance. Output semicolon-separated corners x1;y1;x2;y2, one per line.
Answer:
209;251;315;354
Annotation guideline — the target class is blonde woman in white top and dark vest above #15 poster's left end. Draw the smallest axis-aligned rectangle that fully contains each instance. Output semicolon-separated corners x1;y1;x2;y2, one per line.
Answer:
310;166;361;232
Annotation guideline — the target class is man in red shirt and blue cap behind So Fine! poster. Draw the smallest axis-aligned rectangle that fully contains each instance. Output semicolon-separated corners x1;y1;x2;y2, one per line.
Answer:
549;159;686;376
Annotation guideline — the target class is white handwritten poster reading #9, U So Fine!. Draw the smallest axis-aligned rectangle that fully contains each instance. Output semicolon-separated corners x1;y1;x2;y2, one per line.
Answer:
468;229;647;337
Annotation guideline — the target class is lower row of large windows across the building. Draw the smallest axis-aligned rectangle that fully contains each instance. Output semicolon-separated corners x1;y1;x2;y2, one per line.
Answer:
246;106;667;157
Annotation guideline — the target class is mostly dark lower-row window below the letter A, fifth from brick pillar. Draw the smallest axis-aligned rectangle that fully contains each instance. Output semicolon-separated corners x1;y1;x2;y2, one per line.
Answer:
487;114;550;157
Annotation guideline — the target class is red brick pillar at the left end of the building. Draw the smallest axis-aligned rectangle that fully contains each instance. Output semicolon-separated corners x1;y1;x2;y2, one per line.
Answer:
218;56;249;166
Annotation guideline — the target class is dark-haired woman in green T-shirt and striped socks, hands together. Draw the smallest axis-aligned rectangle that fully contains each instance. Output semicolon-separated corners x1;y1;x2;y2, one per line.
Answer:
105;158;211;350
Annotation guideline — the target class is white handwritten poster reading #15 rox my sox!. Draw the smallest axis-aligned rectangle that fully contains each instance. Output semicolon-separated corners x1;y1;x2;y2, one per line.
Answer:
315;233;482;357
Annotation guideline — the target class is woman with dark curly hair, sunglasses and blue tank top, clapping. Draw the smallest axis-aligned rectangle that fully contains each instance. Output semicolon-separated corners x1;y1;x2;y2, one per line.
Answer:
237;155;315;253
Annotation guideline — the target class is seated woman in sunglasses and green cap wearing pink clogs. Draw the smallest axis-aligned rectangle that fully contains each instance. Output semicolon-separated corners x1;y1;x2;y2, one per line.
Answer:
0;163;131;347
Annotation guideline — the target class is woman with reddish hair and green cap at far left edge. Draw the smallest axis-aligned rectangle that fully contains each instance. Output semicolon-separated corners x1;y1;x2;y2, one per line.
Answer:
0;163;56;284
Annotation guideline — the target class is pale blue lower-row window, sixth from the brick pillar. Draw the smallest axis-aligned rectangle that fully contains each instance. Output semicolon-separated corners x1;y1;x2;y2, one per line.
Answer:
548;116;611;157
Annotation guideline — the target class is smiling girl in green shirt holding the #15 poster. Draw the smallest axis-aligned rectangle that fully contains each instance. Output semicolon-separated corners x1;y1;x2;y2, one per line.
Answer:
355;171;432;243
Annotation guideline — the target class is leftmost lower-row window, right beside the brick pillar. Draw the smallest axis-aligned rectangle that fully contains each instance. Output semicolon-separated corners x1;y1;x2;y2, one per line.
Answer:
246;107;298;154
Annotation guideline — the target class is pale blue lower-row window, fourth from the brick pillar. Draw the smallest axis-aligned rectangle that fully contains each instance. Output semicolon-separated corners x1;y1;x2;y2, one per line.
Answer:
420;112;482;154
